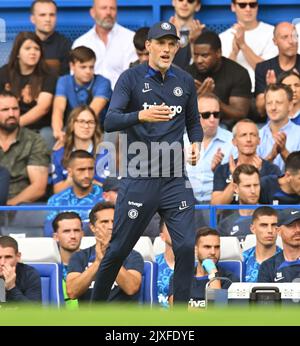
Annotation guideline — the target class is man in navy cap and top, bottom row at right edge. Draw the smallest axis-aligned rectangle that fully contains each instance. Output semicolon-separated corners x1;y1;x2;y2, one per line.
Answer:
257;209;300;282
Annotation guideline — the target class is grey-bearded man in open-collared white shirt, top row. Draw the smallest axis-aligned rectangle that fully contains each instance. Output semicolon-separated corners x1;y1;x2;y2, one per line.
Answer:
72;0;138;88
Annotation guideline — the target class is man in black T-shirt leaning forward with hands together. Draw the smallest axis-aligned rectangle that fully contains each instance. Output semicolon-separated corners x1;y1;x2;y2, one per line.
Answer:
187;31;251;128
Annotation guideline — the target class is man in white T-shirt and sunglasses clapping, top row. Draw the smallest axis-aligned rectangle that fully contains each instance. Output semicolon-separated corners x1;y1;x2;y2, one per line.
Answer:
220;0;278;92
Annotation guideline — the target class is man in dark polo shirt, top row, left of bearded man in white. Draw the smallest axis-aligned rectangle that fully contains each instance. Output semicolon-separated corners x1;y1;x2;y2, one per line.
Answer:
30;0;71;75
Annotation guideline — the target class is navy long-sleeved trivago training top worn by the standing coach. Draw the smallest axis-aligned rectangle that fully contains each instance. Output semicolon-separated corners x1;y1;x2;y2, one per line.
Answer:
104;64;203;178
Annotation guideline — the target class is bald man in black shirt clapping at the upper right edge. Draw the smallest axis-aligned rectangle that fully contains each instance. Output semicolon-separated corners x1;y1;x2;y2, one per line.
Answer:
255;22;300;115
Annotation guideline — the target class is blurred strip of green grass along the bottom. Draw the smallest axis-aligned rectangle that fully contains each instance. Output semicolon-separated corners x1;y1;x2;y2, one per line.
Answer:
0;304;300;326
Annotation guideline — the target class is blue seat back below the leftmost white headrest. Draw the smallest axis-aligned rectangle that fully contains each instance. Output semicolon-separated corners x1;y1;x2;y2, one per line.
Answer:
26;262;64;307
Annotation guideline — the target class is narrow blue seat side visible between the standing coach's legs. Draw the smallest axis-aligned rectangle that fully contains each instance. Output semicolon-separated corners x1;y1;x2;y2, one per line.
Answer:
139;261;158;305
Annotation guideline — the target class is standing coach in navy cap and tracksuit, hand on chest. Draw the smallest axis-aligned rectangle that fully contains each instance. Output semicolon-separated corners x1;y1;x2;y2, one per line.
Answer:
91;22;203;302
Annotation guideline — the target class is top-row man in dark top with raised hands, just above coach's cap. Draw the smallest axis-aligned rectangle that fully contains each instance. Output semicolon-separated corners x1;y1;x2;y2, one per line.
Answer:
169;0;205;69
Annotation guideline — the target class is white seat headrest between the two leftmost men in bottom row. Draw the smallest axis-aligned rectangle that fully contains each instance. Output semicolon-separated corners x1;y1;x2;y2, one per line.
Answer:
17;238;61;263
